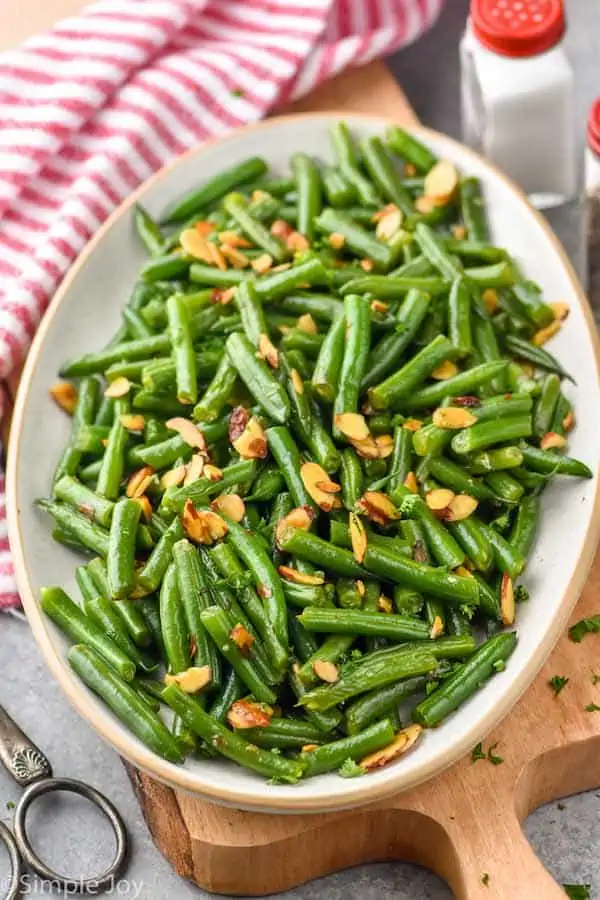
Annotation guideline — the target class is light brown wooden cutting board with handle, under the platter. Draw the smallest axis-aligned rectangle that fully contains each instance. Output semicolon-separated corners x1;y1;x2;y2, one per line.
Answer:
2;42;600;900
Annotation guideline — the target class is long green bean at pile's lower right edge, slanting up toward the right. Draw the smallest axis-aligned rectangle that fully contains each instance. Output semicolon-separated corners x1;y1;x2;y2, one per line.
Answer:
413;631;517;728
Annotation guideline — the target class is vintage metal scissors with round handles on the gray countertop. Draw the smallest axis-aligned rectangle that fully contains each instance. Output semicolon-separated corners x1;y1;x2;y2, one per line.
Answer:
0;706;128;900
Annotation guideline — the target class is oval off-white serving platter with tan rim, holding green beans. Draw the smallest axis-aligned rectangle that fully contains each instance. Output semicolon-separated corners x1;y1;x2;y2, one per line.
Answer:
9;100;600;824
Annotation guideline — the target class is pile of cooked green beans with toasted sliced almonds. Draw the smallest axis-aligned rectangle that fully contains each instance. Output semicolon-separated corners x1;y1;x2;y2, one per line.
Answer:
38;122;592;783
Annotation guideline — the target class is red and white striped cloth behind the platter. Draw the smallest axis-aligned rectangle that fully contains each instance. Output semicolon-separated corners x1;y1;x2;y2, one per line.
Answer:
0;0;443;608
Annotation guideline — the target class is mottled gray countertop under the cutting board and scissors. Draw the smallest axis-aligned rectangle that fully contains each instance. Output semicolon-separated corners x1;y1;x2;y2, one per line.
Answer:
0;0;600;900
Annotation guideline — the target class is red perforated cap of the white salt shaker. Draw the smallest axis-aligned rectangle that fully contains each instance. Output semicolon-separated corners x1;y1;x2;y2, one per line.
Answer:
471;0;565;57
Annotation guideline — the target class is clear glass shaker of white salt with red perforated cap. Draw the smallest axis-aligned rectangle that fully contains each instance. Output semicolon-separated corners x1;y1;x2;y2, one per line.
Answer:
460;0;578;209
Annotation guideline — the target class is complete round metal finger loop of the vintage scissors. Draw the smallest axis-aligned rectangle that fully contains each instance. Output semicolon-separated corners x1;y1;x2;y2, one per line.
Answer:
12;778;128;900
